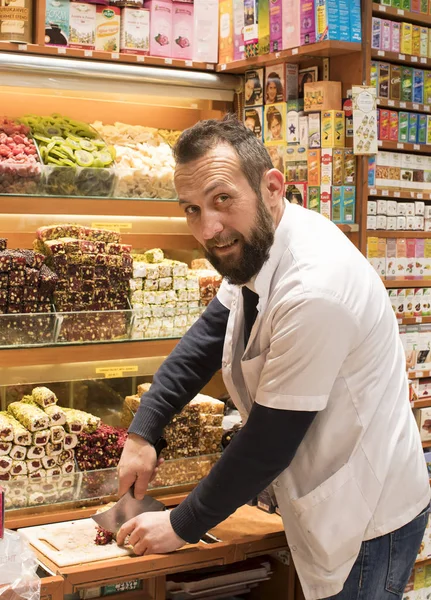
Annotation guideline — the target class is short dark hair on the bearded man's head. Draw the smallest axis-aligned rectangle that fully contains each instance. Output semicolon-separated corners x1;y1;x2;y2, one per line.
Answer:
174;114;273;198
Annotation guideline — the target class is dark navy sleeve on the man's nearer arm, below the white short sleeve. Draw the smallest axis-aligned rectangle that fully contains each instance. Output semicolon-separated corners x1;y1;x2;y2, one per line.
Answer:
171;403;317;543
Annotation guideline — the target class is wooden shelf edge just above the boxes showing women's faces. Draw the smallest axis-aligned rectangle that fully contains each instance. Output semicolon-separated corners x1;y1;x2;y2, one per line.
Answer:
216;40;361;73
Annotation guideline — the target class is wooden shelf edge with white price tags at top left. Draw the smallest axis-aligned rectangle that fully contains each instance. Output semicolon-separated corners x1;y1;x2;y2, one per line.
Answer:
0;42;216;71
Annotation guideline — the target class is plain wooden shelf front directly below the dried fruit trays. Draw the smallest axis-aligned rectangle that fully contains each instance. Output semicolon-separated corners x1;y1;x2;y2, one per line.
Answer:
0;195;184;217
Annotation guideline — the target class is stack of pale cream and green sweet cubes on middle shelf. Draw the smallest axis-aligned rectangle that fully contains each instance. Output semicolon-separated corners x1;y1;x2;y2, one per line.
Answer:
130;248;221;338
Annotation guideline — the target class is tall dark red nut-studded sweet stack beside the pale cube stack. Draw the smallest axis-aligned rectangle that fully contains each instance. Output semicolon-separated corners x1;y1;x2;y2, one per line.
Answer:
34;224;133;342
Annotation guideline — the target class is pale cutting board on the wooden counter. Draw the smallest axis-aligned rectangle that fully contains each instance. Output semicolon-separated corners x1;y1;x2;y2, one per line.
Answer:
18;519;133;567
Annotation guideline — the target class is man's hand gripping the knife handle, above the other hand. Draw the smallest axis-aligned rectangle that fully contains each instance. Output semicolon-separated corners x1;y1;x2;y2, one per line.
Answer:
118;433;163;500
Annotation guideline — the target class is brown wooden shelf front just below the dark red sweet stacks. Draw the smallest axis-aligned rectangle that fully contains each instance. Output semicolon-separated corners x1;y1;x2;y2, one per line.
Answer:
0;339;179;368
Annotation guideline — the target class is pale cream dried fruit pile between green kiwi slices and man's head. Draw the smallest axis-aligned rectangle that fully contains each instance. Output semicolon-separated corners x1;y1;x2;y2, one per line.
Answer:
92;121;181;199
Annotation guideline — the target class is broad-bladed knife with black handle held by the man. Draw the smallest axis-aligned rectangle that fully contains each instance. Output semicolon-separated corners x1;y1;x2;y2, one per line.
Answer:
91;438;167;533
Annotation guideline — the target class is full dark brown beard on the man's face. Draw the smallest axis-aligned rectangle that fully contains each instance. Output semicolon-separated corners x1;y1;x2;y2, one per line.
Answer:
205;198;274;285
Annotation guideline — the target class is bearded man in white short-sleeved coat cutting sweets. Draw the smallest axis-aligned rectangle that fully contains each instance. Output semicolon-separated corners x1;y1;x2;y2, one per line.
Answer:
118;117;429;600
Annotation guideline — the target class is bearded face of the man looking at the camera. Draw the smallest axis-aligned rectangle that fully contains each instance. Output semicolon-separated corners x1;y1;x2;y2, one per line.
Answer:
175;144;274;285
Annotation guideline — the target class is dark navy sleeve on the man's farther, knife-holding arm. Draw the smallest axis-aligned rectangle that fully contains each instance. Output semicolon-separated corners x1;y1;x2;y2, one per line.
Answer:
129;298;229;444
